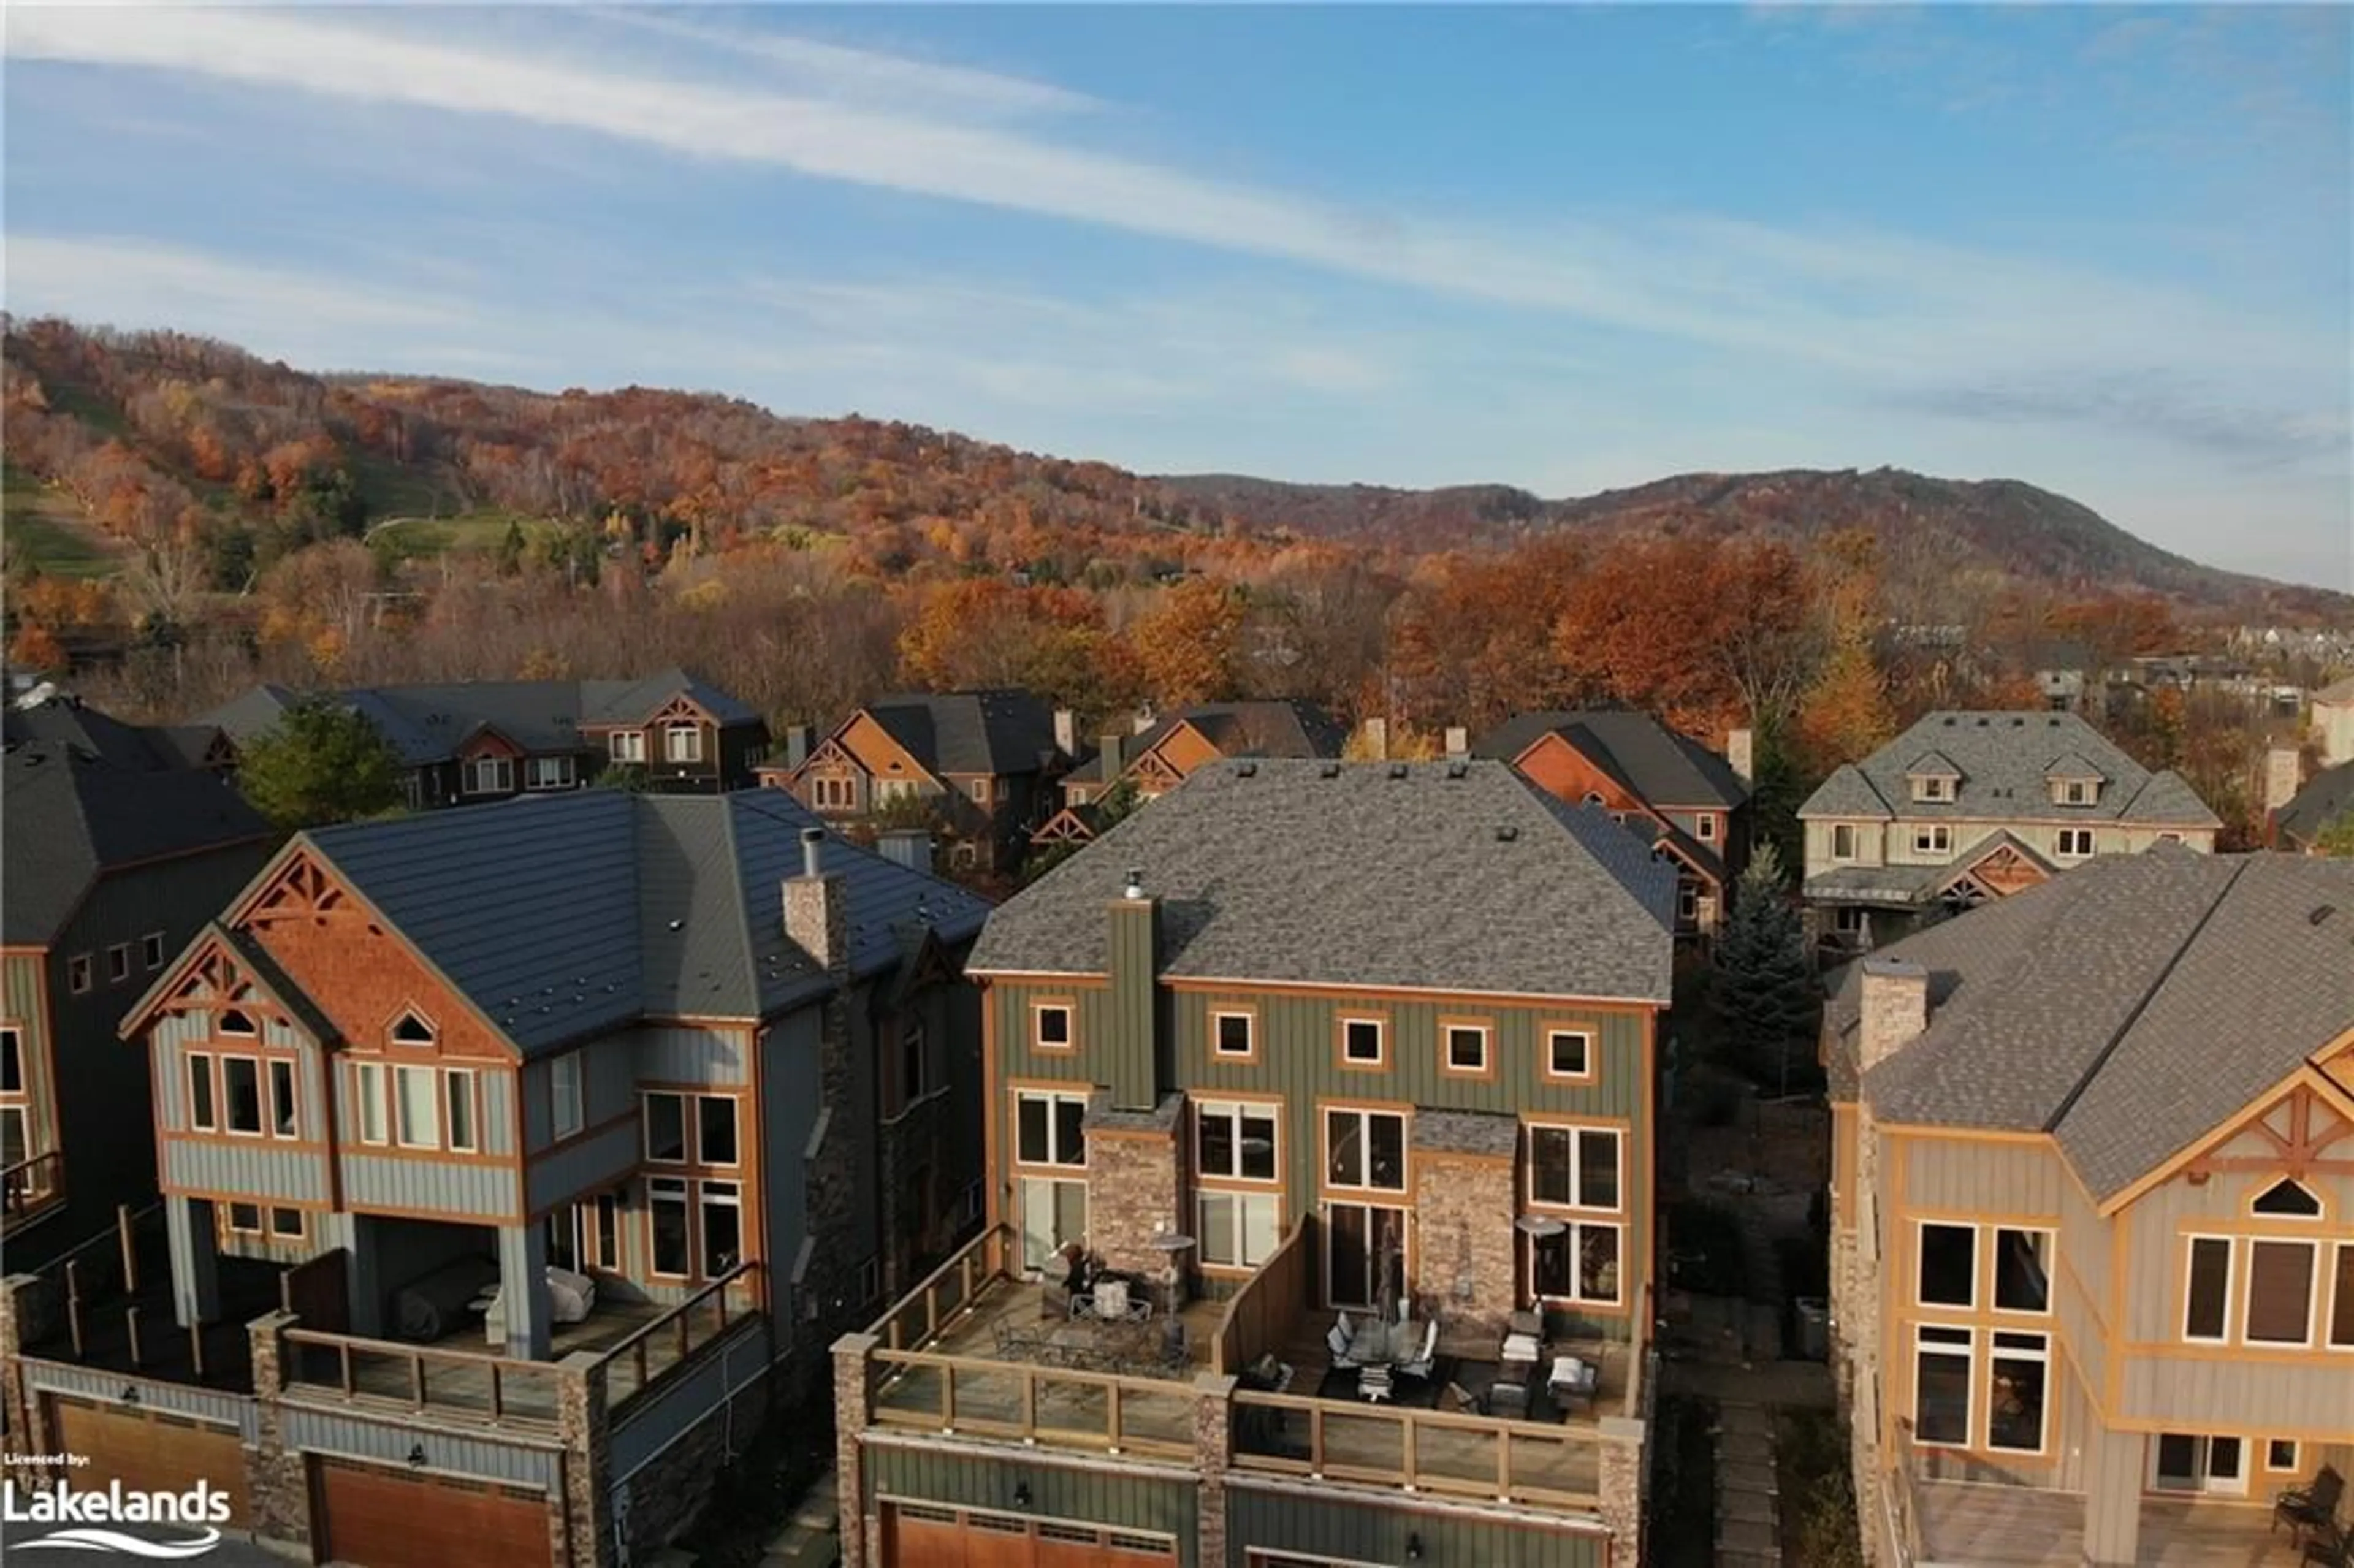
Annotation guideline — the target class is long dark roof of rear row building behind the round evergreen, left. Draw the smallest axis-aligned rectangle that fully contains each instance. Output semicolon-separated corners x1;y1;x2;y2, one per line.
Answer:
205;669;760;767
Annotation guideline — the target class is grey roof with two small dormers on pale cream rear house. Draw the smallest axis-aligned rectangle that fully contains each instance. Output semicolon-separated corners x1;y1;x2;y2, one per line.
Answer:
1799;711;2222;829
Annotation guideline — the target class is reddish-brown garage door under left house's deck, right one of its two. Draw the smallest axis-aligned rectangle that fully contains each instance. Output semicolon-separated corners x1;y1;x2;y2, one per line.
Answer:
311;1455;551;1568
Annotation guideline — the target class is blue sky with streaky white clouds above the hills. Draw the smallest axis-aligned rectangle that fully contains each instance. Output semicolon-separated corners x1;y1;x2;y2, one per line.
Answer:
5;5;2354;588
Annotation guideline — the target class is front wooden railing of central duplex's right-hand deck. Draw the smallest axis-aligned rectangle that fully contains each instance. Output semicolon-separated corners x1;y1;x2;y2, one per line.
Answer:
1233;1391;1603;1509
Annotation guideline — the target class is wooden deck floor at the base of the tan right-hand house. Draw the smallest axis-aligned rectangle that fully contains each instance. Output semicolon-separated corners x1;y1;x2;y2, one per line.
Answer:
1914;1481;2303;1568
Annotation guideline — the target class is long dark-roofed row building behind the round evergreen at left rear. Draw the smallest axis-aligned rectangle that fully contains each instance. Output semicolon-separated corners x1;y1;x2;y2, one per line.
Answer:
202;669;768;810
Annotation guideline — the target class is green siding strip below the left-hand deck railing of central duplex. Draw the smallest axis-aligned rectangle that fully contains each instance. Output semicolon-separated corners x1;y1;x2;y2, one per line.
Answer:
866;1443;1195;1568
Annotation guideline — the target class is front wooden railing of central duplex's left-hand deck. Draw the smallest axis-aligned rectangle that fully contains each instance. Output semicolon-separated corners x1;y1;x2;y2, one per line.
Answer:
874;1349;1196;1462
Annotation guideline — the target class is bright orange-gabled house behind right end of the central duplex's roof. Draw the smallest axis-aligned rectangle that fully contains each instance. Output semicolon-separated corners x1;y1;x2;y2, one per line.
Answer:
1471;709;1751;937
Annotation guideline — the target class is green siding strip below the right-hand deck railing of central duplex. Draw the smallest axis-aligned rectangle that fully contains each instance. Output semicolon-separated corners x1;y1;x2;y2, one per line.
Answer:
1227;1486;1606;1568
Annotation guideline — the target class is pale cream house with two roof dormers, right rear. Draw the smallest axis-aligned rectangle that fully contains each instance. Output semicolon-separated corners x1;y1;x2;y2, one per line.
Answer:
1799;711;2222;954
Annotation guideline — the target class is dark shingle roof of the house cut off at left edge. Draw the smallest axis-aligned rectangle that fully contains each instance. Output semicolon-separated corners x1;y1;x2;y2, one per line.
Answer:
0;742;271;946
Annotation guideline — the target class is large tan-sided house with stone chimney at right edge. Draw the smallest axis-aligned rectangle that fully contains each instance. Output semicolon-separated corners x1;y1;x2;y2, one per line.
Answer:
1824;848;2354;1568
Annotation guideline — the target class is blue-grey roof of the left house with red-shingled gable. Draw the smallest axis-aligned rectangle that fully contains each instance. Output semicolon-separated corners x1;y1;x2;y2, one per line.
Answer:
306;789;986;1055
